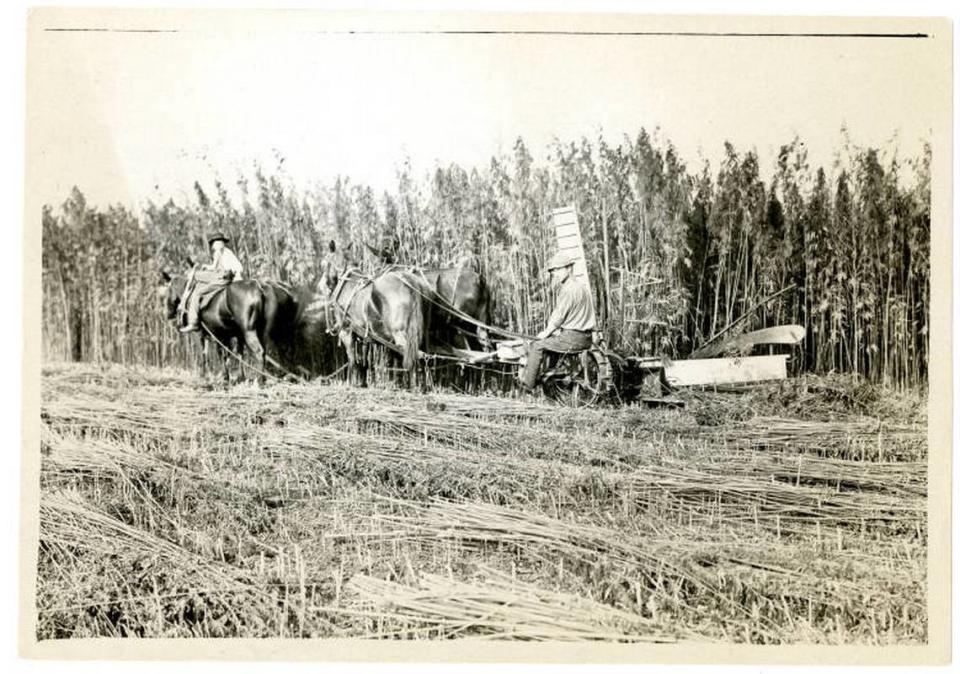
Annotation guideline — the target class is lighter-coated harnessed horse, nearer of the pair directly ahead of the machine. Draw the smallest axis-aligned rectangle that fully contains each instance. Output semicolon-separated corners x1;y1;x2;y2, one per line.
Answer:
321;241;430;387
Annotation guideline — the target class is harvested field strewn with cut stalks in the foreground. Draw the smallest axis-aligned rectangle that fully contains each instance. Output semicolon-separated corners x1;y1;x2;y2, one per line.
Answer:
37;365;927;644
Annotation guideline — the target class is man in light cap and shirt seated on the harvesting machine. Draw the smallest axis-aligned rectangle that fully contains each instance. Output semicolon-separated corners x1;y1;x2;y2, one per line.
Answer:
520;253;597;391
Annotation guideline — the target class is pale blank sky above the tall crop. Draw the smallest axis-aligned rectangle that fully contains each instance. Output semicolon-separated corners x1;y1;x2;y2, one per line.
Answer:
28;15;936;207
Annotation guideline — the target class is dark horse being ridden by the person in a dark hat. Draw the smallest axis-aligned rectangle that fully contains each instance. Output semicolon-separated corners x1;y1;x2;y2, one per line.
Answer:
159;271;296;385
